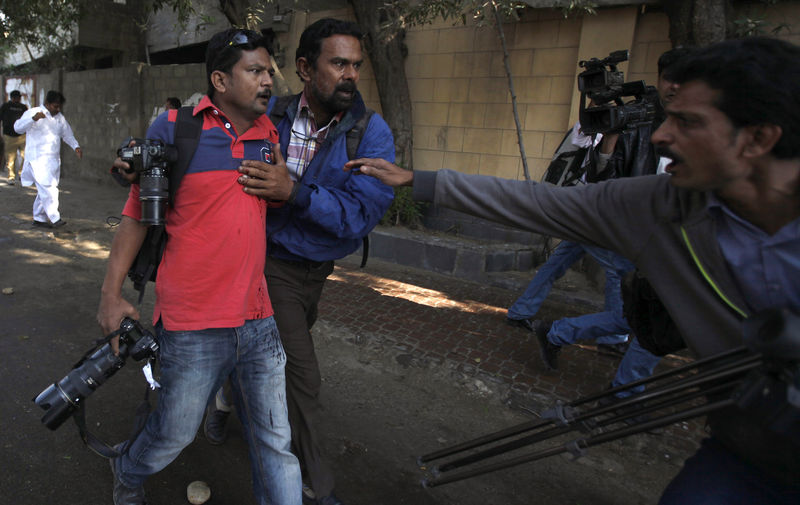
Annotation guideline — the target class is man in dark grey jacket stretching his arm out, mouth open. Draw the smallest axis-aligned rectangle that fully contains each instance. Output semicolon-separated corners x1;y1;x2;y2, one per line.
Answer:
346;38;800;505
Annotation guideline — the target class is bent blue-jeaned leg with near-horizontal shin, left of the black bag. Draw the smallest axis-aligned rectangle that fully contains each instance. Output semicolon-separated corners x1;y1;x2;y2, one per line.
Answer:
547;244;633;345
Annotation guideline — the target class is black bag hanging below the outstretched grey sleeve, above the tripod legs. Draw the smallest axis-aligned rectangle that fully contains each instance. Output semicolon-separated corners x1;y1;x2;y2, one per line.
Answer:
622;270;686;356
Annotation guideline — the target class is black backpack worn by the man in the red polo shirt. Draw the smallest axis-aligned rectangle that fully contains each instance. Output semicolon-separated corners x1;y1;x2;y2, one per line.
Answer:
128;107;203;304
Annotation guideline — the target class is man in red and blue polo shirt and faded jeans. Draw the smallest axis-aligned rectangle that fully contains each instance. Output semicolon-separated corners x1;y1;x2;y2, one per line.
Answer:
97;29;301;505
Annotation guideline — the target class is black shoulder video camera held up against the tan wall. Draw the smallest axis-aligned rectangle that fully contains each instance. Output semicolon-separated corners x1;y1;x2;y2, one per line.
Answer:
578;49;660;135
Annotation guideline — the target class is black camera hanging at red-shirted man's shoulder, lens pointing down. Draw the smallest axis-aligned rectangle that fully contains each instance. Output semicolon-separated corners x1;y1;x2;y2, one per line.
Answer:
117;139;178;225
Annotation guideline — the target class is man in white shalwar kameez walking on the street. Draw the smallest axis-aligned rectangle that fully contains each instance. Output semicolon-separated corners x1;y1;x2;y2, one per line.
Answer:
14;91;83;228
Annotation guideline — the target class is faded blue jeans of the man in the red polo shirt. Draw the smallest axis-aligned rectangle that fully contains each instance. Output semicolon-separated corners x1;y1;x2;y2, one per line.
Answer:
115;317;302;505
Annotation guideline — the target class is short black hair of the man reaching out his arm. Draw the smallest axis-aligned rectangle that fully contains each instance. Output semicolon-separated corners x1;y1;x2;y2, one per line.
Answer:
669;37;800;159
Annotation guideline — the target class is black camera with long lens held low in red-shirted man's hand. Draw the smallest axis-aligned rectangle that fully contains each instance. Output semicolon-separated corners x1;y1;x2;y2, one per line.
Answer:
33;317;158;430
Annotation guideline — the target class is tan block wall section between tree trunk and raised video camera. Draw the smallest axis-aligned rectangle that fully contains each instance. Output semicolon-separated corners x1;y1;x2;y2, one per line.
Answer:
406;10;582;179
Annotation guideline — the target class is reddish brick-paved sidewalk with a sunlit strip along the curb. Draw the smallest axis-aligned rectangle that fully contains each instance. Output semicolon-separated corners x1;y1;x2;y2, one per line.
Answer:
320;257;703;450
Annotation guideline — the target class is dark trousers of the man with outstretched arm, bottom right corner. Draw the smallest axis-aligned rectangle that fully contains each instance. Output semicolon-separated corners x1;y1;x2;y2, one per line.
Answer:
658;437;800;505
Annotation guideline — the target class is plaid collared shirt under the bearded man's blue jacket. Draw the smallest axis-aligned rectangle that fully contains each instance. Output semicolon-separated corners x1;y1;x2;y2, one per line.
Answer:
286;92;344;181
